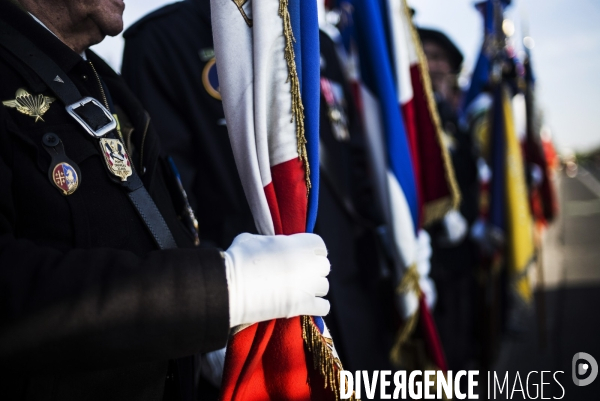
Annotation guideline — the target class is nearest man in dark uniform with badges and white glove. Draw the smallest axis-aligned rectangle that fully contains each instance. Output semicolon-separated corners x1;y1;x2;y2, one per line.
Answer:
0;0;329;401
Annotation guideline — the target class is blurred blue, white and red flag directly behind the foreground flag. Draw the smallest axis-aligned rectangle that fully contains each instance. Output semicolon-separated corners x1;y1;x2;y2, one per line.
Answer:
352;0;446;370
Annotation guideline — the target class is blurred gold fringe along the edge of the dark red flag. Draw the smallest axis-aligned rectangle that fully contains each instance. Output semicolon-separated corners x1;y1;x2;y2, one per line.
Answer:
402;0;460;226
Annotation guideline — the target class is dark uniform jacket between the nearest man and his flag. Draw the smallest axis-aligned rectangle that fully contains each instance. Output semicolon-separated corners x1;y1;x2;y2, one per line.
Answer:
123;0;256;247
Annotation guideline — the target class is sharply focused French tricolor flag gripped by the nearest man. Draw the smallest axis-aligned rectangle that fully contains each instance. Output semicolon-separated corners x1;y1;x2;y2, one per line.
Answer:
211;0;341;401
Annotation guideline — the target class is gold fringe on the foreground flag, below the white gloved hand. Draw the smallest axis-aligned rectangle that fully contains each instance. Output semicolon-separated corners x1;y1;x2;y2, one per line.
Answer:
300;316;360;401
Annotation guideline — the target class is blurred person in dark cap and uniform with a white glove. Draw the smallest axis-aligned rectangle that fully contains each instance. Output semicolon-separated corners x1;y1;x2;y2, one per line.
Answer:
418;28;479;370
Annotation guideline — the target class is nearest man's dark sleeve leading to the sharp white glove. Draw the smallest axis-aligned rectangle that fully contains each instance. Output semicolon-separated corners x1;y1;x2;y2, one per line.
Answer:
0;107;229;373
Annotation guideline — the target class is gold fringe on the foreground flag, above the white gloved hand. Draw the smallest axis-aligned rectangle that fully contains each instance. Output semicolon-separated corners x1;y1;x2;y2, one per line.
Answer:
279;0;312;195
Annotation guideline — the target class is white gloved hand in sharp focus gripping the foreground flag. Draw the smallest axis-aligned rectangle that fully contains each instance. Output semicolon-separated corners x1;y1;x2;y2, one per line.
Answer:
224;233;330;327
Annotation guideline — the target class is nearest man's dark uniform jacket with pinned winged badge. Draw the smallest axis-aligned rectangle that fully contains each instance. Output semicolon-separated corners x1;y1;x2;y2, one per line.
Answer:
0;1;229;401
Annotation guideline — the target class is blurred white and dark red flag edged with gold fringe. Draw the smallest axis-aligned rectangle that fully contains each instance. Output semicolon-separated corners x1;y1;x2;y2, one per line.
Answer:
386;0;460;226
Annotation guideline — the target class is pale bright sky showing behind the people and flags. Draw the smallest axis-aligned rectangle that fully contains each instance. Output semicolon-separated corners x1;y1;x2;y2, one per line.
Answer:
94;0;600;151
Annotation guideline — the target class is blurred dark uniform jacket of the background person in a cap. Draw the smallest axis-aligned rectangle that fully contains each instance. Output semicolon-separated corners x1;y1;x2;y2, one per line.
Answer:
428;96;479;370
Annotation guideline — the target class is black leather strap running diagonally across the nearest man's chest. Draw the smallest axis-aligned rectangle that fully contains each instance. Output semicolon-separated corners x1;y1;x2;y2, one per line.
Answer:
0;20;177;249
